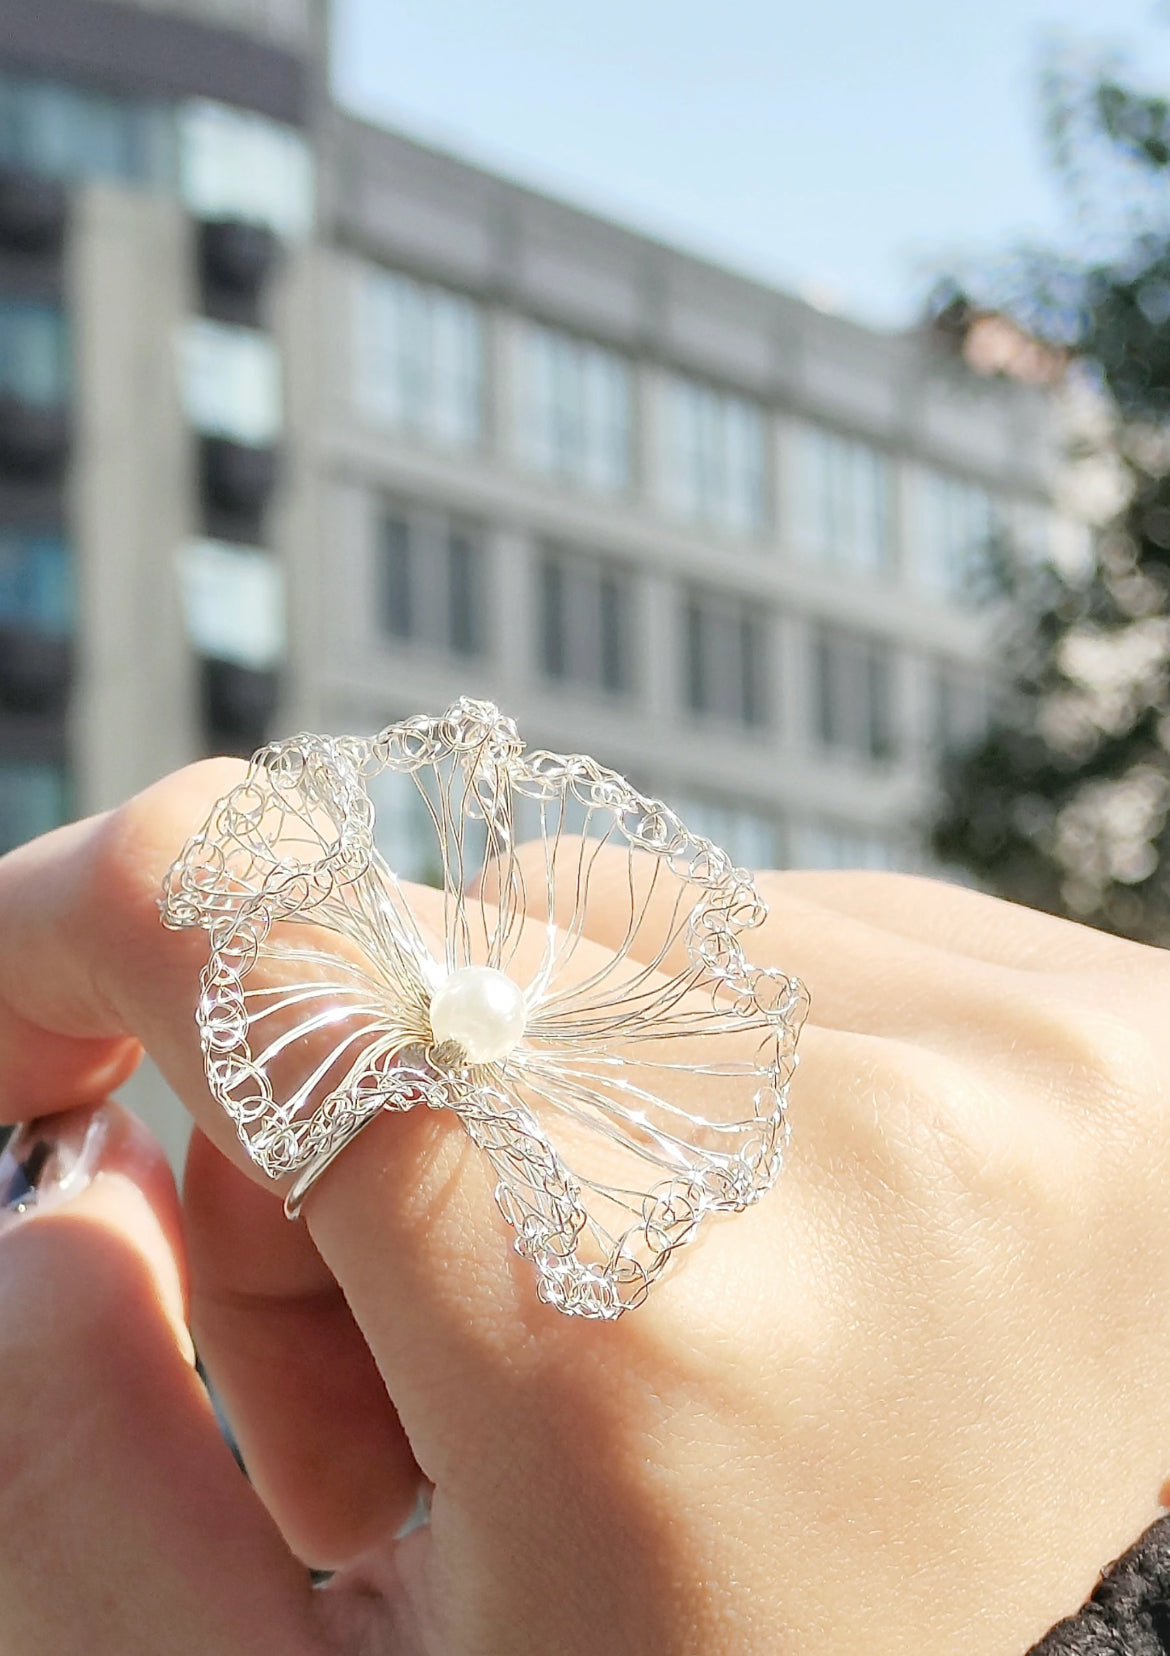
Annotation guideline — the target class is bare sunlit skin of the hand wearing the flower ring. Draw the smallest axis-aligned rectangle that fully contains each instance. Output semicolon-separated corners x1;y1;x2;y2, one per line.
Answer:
0;762;1170;1656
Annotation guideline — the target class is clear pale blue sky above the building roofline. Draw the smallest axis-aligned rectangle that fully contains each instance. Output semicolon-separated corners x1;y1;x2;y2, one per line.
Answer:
334;0;1170;325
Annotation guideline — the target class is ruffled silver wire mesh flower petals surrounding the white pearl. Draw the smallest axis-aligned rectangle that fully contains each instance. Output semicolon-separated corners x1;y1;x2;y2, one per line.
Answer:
162;699;808;1318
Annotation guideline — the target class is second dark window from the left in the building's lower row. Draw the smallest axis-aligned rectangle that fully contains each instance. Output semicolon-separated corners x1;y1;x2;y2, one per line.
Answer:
538;548;634;694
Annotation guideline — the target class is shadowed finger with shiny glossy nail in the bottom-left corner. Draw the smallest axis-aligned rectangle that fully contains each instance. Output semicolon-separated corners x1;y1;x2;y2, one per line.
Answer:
0;1106;321;1656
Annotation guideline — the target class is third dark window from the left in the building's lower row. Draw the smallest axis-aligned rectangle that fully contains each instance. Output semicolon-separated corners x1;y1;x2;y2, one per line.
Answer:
683;593;768;725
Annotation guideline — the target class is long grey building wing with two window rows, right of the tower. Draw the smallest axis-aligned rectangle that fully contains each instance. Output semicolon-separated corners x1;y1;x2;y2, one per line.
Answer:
304;113;1061;866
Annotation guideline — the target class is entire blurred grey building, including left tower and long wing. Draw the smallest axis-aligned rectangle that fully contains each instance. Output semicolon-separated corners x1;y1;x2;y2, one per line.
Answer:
0;0;1067;1152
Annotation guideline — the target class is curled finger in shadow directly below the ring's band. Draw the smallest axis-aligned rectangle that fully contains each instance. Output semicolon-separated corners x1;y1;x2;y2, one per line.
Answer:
184;1133;420;1570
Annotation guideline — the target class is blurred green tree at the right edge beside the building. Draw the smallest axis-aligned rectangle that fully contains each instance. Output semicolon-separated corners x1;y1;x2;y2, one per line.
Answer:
933;51;1170;944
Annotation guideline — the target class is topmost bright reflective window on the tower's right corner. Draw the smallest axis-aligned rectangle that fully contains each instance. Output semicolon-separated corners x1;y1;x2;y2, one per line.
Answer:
177;98;313;238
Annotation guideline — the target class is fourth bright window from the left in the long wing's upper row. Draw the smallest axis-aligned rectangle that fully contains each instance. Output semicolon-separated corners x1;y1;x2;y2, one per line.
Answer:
791;426;894;575
